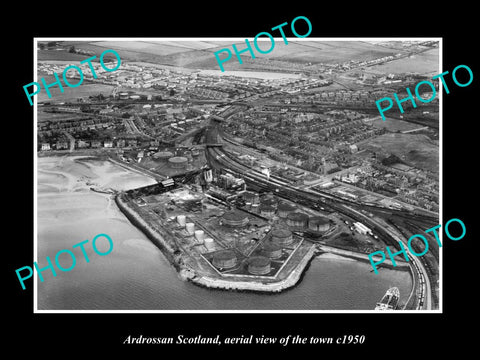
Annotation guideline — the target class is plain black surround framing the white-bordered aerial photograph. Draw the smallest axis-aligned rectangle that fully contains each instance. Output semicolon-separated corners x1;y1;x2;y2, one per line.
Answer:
6;2;480;357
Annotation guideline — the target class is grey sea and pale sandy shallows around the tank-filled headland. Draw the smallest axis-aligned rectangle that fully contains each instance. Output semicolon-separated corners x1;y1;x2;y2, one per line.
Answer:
37;156;412;311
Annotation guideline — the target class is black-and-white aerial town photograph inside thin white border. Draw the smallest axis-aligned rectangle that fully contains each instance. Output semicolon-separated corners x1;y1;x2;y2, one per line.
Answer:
32;38;442;312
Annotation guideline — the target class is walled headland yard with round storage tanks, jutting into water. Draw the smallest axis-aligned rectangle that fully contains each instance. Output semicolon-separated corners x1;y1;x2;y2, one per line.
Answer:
111;144;412;292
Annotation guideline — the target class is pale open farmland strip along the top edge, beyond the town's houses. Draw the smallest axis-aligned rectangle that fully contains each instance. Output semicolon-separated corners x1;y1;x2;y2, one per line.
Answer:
34;40;439;75
